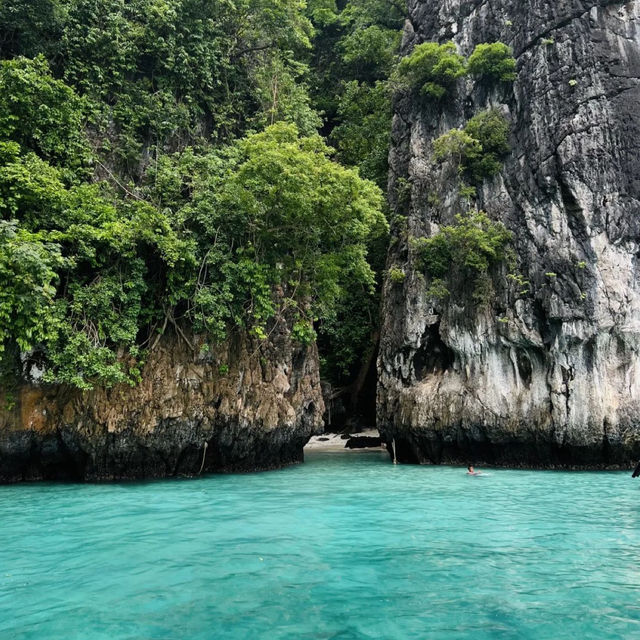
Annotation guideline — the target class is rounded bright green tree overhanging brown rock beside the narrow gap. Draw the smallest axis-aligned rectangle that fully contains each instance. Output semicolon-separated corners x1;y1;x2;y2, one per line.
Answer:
178;124;386;338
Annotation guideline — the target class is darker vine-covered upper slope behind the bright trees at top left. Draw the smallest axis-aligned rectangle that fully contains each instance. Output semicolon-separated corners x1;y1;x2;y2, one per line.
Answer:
0;0;319;179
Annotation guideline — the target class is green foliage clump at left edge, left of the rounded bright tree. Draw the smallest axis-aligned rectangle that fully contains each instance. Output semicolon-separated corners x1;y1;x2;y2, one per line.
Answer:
0;59;185;388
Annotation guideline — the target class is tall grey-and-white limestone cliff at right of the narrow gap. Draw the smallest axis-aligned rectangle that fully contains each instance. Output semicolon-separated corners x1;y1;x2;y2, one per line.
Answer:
377;0;640;467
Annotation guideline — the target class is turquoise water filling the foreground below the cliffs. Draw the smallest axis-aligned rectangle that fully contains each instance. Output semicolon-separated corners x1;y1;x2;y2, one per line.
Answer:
0;453;640;640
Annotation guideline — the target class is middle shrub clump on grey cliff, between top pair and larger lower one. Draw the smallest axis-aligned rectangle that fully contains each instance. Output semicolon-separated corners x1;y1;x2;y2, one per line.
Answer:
433;109;510;181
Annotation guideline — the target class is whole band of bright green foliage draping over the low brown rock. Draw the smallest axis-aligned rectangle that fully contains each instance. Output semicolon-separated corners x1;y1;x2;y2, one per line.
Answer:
0;118;386;388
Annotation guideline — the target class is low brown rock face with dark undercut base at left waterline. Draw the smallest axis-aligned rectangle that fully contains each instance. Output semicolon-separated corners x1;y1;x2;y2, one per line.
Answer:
0;326;324;482
